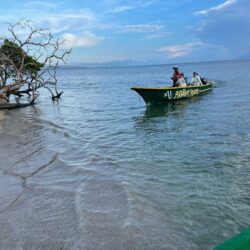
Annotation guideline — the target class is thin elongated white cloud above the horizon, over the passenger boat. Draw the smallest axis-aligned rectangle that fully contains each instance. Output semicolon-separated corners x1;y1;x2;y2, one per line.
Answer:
159;42;217;58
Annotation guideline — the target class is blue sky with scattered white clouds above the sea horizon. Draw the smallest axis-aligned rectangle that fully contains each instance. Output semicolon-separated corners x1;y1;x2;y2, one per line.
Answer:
0;0;250;64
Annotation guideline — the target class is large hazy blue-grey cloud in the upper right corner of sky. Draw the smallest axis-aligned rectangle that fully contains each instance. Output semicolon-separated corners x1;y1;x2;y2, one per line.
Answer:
196;0;250;59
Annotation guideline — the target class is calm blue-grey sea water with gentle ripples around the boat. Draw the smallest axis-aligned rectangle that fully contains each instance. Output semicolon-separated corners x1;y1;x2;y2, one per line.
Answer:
0;61;250;250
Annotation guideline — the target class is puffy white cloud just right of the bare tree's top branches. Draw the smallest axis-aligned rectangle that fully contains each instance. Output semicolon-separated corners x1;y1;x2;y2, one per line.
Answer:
62;31;104;48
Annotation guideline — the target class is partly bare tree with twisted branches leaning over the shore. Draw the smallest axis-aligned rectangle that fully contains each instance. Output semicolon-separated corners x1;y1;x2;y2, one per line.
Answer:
0;20;71;104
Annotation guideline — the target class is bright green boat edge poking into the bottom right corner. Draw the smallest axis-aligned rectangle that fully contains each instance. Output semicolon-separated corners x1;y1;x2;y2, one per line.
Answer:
213;228;250;250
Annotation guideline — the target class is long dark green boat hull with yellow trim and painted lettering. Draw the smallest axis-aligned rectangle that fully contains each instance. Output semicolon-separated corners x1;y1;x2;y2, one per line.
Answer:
131;82;213;105
